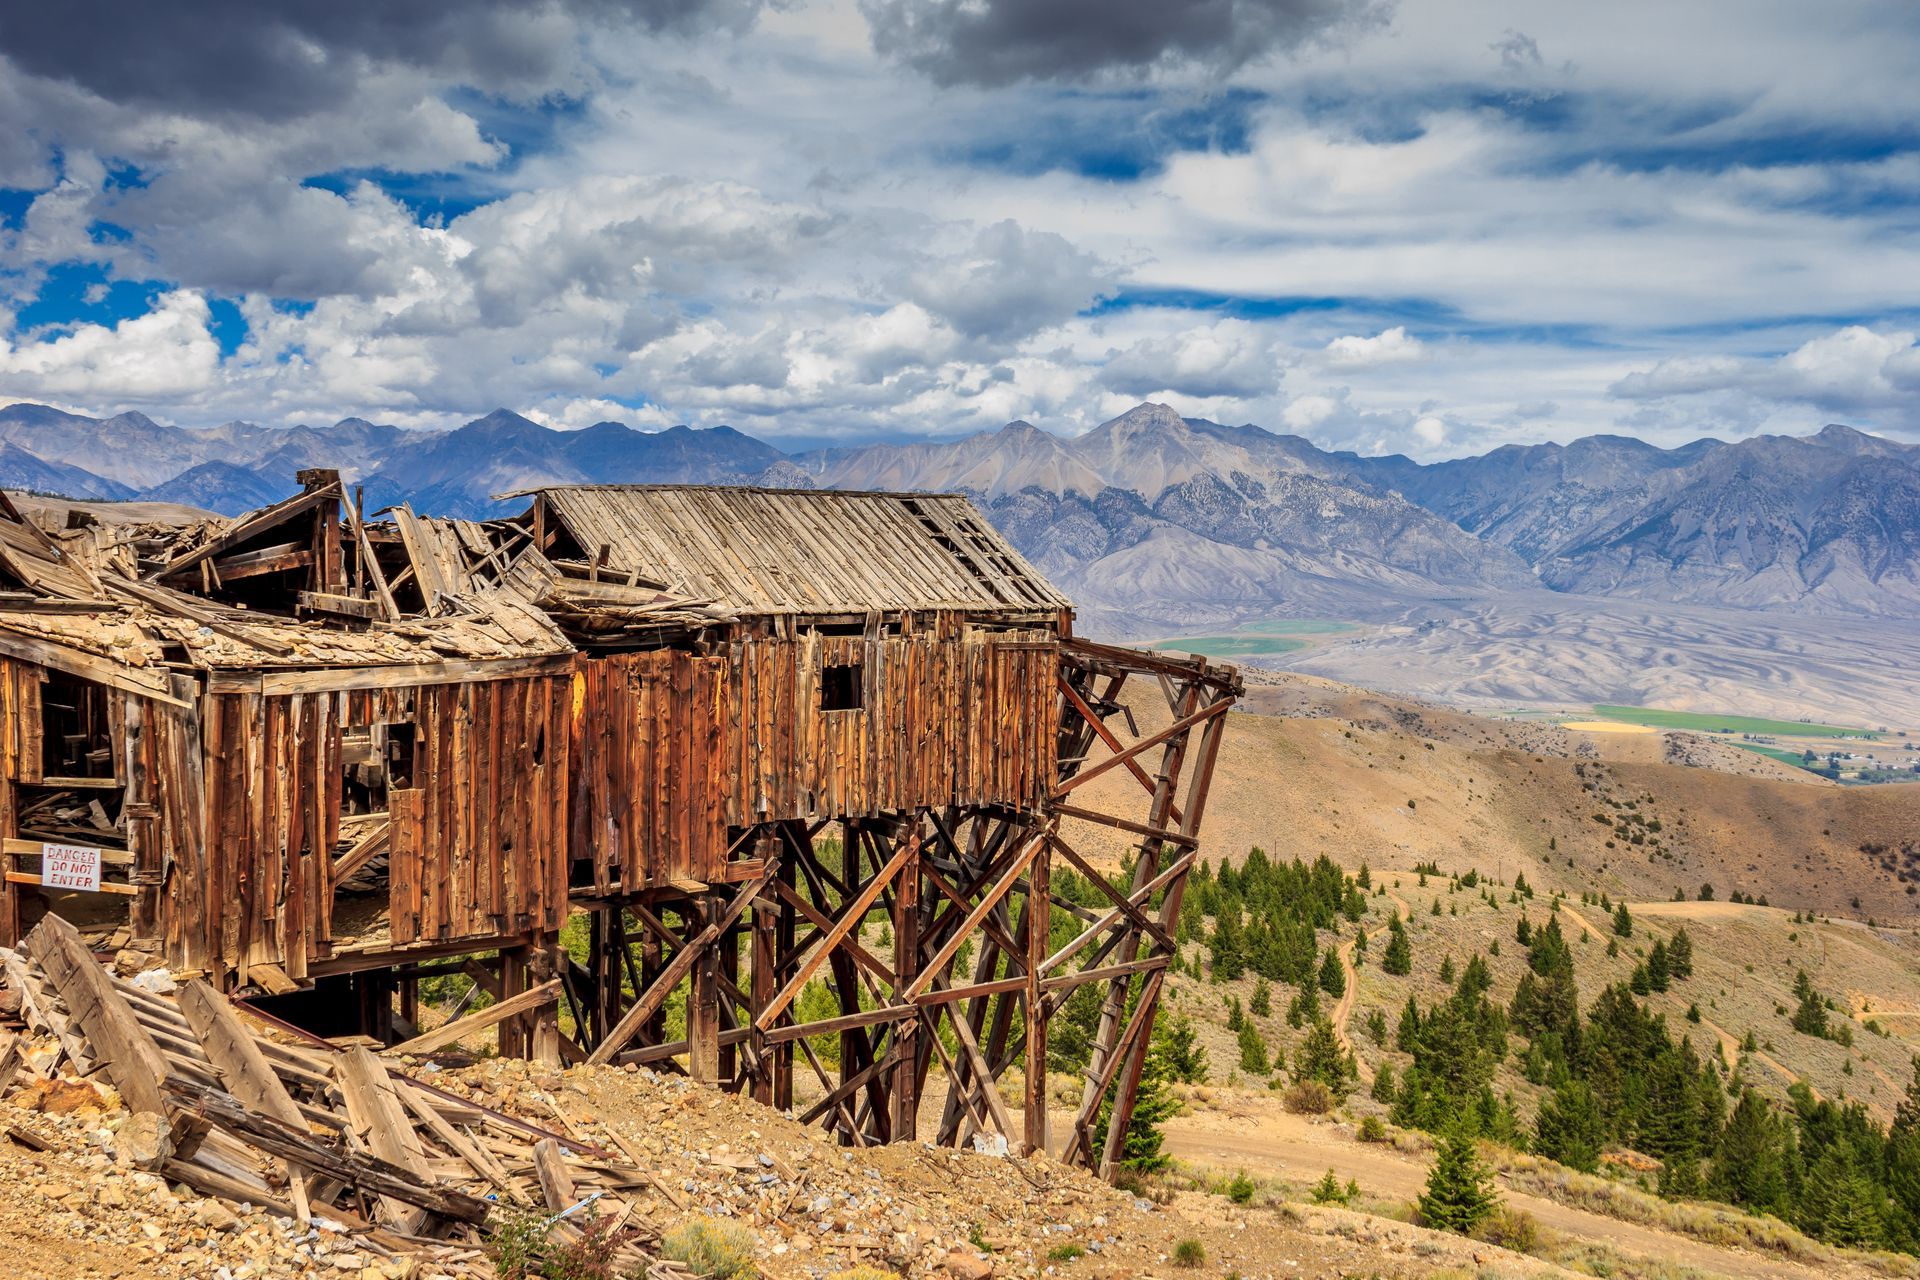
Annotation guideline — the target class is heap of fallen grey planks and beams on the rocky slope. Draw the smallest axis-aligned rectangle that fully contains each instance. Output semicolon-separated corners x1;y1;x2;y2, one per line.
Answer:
0;915;691;1280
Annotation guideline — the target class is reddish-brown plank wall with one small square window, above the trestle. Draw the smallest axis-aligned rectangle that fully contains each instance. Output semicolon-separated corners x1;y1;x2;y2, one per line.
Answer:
574;629;1058;892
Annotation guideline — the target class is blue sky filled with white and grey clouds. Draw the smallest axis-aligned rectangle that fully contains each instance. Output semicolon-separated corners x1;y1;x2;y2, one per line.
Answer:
0;0;1920;459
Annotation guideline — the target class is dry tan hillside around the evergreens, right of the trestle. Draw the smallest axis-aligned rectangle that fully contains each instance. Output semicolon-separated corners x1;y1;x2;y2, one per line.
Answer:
1071;676;1920;1276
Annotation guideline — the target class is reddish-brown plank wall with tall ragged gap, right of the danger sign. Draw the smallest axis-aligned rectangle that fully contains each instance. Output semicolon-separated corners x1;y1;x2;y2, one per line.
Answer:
173;676;568;977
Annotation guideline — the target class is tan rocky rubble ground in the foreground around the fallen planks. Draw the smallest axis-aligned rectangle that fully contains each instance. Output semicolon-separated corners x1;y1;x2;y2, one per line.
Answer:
0;1028;1589;1280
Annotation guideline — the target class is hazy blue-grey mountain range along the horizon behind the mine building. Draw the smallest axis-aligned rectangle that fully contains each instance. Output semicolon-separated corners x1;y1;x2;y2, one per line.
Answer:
0;403;1920;633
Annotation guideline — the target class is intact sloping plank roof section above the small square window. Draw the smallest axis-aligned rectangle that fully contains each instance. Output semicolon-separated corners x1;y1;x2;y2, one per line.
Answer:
538;486;1071;614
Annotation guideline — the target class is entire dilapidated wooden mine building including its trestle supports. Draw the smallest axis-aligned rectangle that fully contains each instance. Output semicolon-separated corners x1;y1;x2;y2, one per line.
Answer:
0;470;1240;1173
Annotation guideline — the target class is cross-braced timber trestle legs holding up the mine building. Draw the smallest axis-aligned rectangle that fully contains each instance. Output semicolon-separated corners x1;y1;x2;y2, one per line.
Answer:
561;639;1242;1176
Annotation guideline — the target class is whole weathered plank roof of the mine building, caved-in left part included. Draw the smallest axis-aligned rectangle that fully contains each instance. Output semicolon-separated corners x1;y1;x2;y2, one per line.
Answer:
0;470;1071;697
